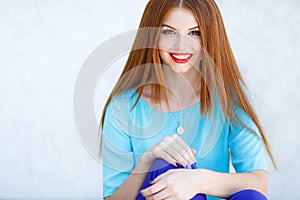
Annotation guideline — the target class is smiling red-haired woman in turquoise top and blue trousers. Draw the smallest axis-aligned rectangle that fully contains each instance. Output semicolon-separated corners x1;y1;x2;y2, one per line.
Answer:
101;0;274;199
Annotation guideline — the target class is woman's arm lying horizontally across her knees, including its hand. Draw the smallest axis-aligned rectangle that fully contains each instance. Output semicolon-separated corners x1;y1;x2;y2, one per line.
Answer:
141;169;268;199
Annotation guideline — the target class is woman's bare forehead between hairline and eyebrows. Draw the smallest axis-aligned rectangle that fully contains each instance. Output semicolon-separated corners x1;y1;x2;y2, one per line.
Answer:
162;8;198;29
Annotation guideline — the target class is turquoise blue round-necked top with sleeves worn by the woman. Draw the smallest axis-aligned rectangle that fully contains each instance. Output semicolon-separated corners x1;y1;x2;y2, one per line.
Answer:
102;89;267;200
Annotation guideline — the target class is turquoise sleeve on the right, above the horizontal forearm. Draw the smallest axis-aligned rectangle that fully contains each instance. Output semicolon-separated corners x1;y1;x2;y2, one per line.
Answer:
229;109;267;173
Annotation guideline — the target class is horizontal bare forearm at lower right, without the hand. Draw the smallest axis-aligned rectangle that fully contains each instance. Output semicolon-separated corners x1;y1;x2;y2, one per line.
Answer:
197;169;268;198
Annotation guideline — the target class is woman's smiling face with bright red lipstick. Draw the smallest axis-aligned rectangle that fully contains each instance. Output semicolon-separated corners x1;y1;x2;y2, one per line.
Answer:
158;8;202;73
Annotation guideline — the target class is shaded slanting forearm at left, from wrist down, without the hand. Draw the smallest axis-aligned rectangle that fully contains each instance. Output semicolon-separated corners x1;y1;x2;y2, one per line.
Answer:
105;158;152;200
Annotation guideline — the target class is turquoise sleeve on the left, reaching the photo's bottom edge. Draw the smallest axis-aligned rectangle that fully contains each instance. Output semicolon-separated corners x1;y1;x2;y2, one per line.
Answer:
102;103;134;198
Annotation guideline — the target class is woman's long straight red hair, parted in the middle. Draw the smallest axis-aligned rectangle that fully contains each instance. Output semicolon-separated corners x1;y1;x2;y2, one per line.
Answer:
101;0;277;168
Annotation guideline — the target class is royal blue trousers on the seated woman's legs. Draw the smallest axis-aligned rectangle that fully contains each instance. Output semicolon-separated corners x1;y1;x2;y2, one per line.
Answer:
137;159;267;200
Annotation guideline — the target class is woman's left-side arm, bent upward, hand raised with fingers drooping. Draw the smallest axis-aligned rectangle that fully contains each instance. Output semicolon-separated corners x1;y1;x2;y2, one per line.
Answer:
105;134;196;200
